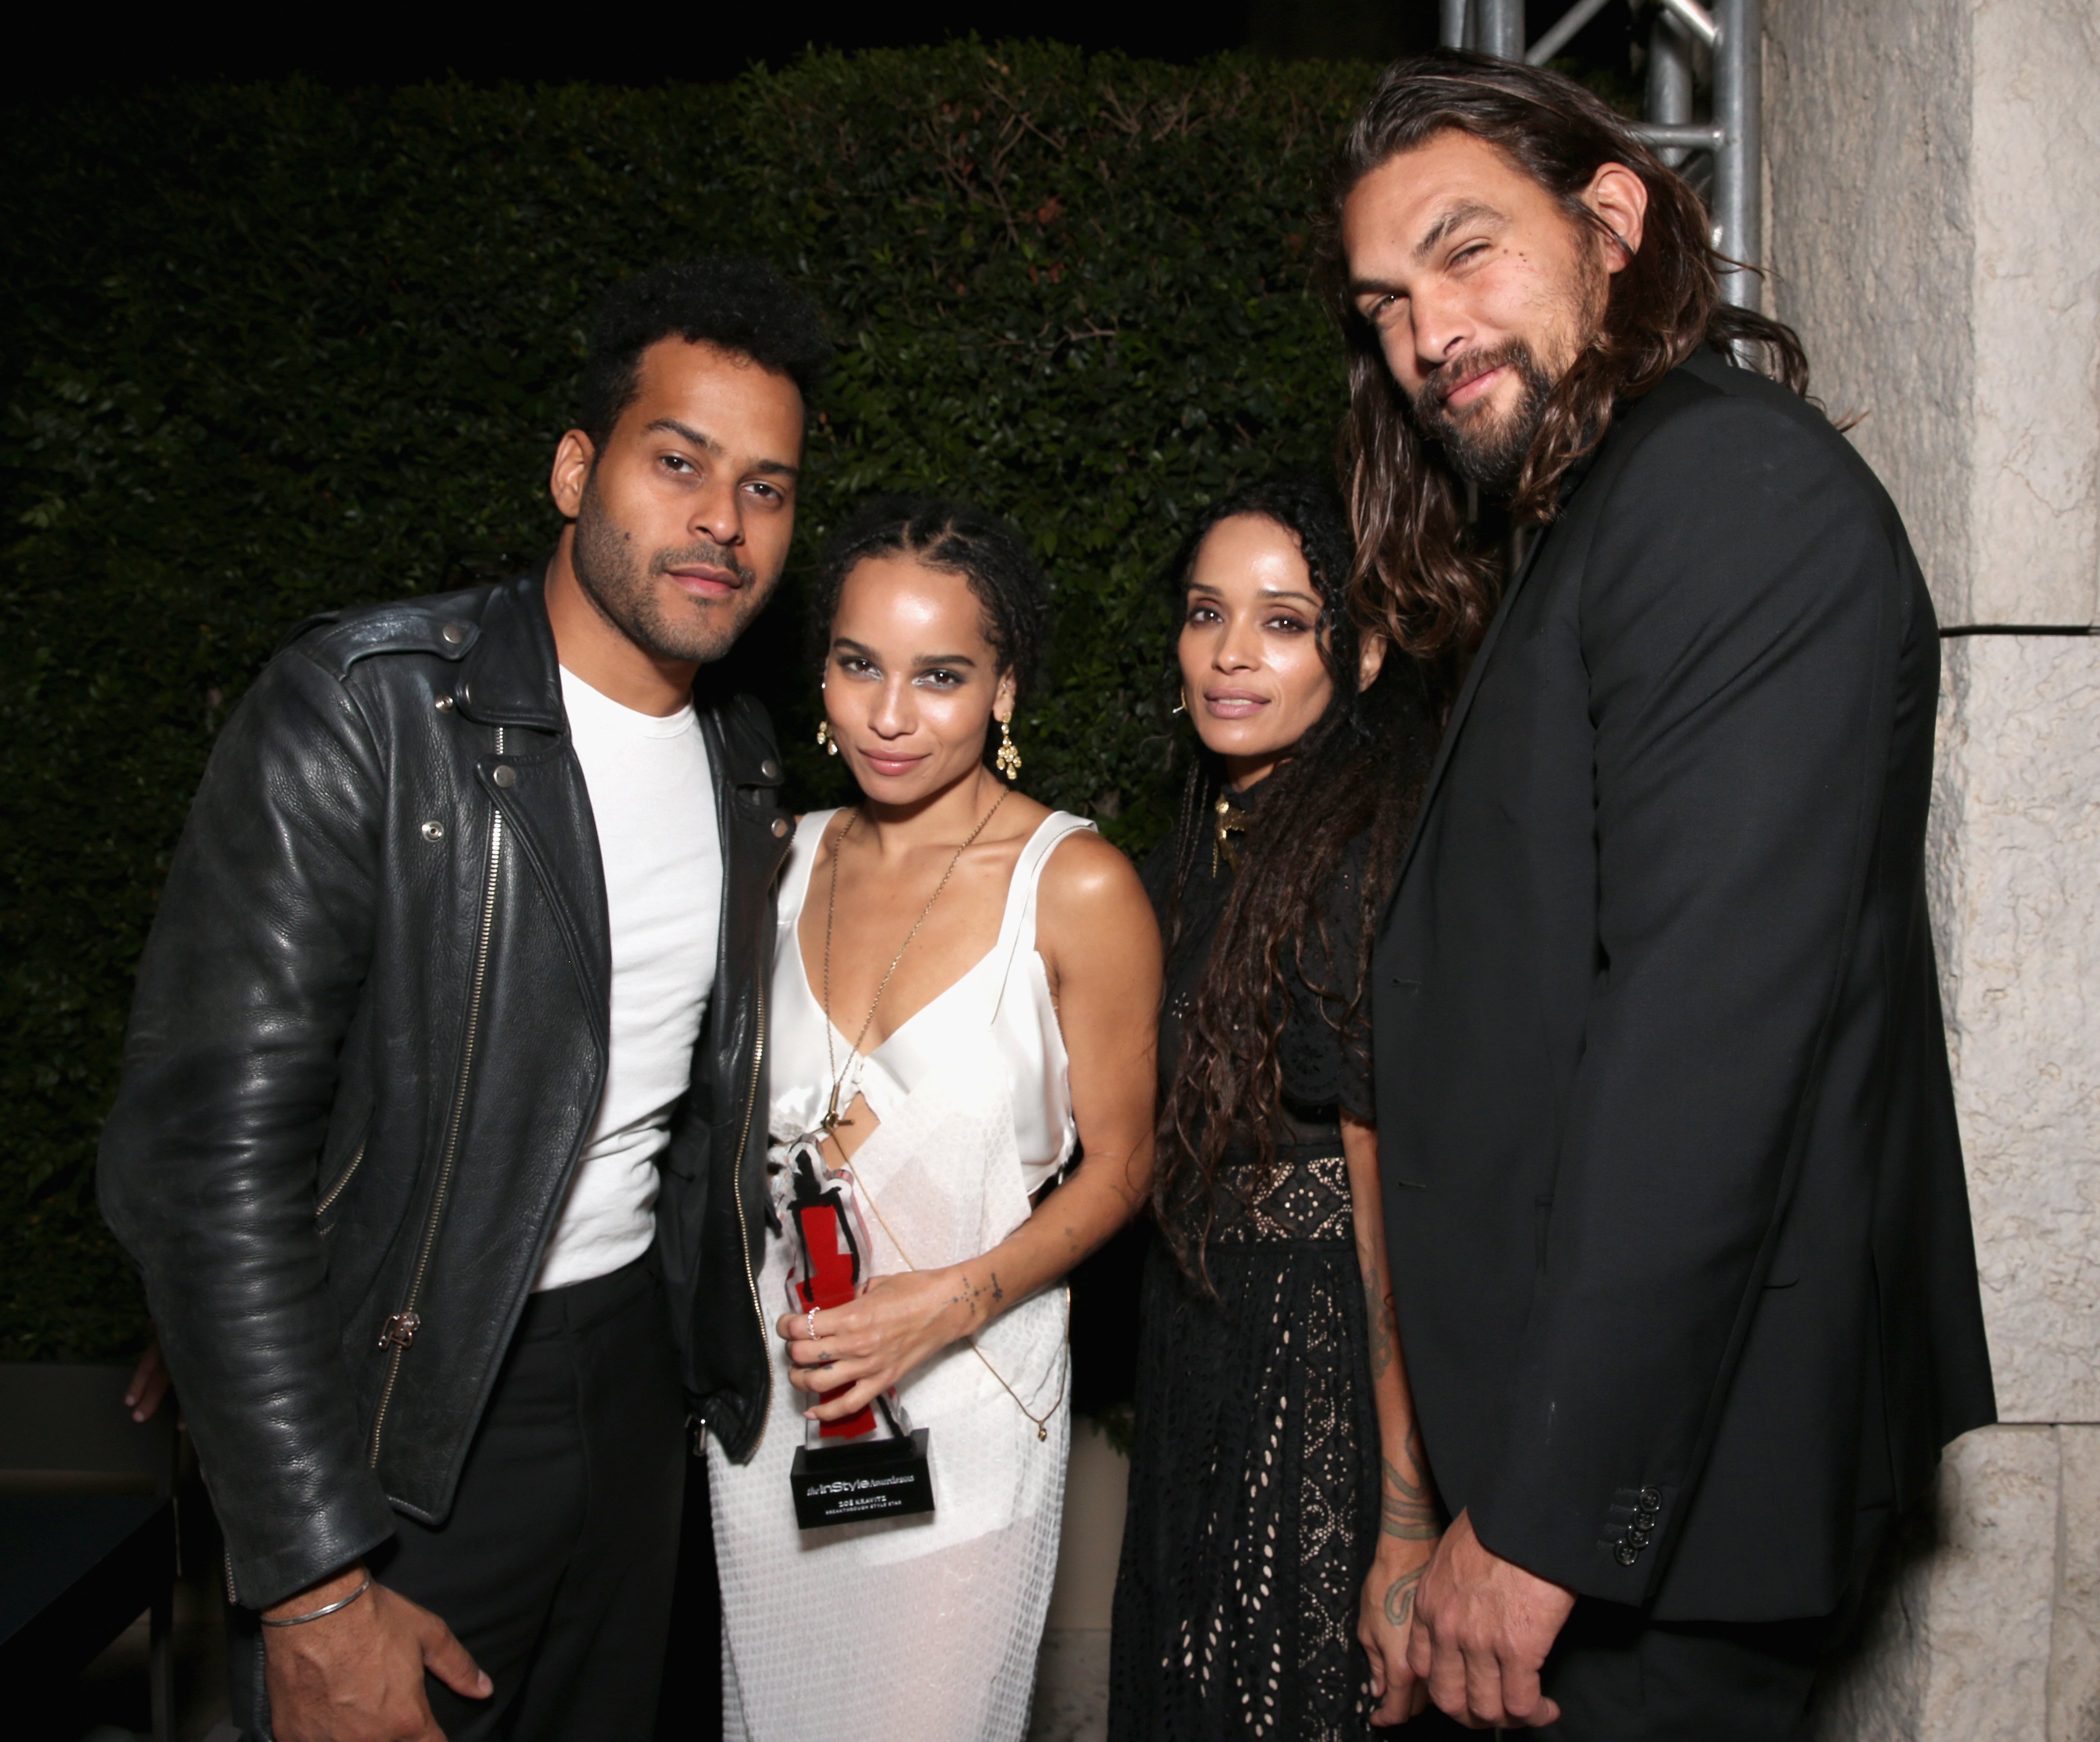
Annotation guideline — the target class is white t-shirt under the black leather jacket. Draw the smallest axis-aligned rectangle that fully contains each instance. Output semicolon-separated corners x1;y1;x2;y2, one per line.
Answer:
533;670;722;1289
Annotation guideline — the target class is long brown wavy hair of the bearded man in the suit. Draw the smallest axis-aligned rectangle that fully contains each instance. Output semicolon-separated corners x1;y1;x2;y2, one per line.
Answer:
1319;50;1808;674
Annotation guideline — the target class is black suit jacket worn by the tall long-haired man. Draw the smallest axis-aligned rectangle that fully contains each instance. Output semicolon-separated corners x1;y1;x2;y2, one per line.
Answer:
1374;352;1995;1621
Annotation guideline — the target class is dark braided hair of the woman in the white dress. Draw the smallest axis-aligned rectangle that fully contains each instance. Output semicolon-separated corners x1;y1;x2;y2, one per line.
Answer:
809;495;1050;699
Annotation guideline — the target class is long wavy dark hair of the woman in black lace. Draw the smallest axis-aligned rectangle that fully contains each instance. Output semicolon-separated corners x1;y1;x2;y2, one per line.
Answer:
1153;477;1435;1276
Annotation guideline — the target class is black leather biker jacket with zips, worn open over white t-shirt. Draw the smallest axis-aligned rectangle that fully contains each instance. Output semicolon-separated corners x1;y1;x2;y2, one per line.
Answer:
101;575;794;1606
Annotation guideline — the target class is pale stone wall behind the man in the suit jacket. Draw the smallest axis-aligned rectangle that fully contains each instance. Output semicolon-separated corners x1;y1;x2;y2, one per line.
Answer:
1766;0;2100;1742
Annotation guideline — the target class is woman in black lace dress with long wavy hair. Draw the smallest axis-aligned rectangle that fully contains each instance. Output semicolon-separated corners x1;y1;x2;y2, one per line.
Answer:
1109;481;1441;1742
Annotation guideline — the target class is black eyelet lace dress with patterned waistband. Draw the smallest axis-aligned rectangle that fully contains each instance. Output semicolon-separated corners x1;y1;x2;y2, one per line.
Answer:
1109;793;1392;1742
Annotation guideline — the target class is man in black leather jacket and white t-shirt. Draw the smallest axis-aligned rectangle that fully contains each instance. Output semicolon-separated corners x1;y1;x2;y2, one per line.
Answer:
101;260;827;1742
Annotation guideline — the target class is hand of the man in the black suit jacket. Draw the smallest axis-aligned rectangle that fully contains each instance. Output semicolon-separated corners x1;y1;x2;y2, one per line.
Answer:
1407;1513;1575;1729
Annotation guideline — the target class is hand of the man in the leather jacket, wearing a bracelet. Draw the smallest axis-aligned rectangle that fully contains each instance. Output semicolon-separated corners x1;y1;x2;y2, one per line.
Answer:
262;1566;496;1742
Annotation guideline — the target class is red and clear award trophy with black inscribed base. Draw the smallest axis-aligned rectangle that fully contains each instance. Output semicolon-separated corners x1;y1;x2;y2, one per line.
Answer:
788;1140;932;1530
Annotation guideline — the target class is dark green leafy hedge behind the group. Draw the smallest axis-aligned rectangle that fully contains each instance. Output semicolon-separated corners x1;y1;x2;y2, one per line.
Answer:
0;42;1369;1358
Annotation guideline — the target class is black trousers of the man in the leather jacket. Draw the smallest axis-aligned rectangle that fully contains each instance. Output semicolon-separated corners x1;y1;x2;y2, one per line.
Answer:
235;1259;684;1742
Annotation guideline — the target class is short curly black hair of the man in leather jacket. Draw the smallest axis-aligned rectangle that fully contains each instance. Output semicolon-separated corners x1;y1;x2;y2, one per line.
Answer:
578;258;832;451
